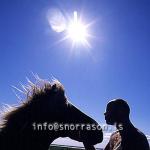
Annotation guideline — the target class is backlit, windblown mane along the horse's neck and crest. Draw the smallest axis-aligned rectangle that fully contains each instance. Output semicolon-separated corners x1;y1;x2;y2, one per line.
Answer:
0;78;65;129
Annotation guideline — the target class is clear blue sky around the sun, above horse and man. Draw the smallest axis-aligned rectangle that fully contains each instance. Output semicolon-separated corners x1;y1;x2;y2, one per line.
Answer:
0;0;150;139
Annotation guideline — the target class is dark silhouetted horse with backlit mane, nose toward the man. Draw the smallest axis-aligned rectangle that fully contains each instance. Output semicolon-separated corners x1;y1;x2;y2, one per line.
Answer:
0;78;103;150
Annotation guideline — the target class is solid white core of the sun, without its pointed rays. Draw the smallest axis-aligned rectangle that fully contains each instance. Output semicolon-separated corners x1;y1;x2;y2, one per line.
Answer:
67;11;89;46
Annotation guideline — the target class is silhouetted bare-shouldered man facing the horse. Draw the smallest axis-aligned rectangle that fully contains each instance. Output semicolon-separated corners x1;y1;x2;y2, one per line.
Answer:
104;99;150;150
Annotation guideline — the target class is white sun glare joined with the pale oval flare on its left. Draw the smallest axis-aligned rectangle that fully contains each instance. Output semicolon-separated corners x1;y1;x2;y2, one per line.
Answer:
47;9;92;48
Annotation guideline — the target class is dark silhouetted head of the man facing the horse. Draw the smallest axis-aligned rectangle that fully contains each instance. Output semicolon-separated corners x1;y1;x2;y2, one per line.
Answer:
104;99;130;125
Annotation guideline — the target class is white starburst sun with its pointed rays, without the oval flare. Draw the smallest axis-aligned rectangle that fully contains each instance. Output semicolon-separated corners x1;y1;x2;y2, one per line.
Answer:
48;11;95;51
